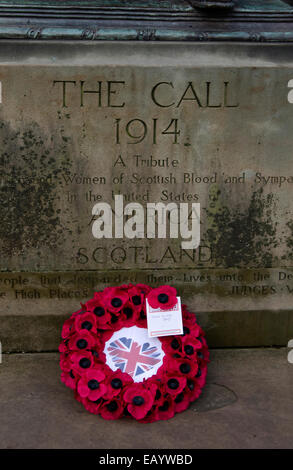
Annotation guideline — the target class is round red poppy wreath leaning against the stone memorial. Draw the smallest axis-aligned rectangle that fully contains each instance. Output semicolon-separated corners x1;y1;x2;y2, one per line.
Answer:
59;284;209;423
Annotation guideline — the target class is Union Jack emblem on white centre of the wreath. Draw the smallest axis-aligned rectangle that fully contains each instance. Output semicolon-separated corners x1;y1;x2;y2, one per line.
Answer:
107;337;162;379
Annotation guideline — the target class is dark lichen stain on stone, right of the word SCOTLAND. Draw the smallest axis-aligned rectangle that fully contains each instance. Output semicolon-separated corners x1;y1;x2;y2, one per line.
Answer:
202;186;278;267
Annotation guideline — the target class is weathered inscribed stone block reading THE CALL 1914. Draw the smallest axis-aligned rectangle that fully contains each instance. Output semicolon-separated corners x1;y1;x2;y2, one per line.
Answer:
0;43;293;350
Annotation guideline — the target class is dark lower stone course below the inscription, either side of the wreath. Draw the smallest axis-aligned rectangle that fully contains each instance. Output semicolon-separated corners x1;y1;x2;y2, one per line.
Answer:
1;308;293;352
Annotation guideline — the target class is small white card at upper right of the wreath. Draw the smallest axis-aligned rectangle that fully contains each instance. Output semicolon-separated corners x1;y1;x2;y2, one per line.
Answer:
146;297;183;337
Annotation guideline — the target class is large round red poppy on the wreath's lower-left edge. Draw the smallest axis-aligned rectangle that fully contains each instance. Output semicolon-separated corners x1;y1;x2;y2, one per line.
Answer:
77;369;107;401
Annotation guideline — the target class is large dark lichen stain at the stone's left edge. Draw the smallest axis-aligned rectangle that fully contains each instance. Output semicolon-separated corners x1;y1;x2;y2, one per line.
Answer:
0;122;71;257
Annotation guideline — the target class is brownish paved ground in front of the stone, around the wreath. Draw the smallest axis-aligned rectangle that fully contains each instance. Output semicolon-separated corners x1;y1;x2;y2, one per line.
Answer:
0;348;293;449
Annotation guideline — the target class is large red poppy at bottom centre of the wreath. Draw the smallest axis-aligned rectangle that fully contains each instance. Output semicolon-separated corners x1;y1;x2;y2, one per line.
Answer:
123;383;154;419
